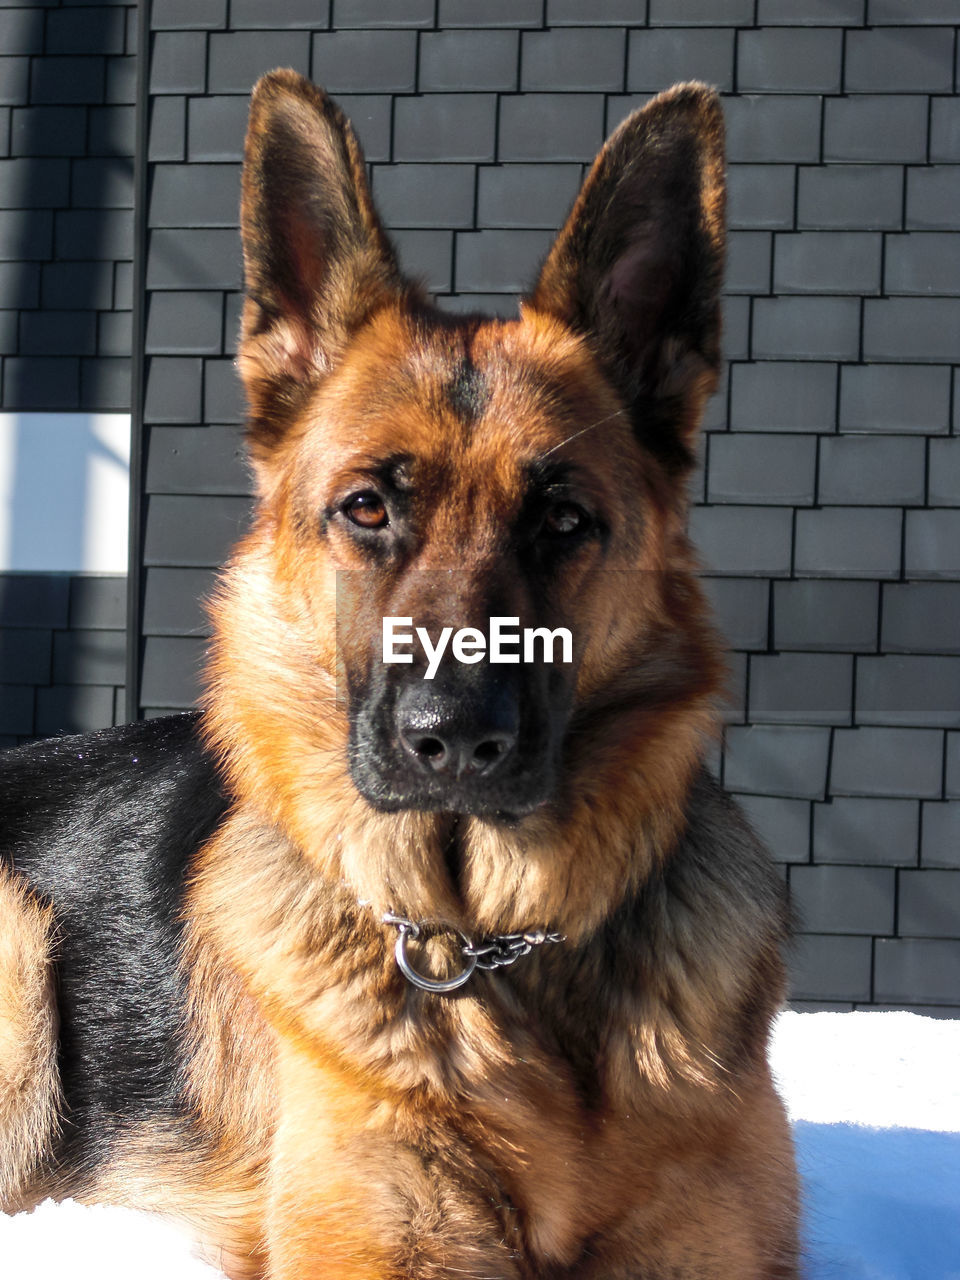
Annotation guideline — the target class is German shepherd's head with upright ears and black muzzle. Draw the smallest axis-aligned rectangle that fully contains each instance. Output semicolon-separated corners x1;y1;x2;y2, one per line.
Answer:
217;72;723;818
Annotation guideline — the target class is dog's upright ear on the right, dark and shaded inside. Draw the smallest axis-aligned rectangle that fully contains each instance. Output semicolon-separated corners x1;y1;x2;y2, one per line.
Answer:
529;84;724;470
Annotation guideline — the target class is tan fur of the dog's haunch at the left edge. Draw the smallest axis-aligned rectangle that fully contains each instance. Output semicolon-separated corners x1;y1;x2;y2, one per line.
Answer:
0;868;60;1212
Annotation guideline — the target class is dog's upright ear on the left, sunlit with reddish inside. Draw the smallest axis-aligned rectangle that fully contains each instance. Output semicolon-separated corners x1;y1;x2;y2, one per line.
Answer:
238;70;407;460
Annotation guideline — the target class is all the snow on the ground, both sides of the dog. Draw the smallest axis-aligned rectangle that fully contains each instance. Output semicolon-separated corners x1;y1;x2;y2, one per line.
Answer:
0;1012;960;1280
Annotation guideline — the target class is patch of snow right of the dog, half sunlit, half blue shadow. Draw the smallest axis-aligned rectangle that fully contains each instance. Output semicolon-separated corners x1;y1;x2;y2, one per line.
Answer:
773;1012;960;1280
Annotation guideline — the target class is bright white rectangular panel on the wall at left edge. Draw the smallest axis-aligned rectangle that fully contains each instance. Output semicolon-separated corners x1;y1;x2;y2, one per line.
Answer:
0;413;131;573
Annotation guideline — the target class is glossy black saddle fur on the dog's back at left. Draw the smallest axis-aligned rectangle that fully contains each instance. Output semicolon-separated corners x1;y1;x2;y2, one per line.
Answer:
0;716;227;1165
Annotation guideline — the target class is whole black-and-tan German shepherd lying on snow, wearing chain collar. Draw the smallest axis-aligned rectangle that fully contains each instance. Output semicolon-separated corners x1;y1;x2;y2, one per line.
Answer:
0;70;797;1280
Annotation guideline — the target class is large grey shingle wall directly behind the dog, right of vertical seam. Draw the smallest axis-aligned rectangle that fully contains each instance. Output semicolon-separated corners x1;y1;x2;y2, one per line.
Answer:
0;0;960;1011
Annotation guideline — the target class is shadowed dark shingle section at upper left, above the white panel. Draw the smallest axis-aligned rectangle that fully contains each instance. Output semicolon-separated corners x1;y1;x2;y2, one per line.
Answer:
0;0;137;411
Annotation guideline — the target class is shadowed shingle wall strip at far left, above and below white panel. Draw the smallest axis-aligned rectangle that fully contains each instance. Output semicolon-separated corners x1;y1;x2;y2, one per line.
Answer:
0;0;137;746
